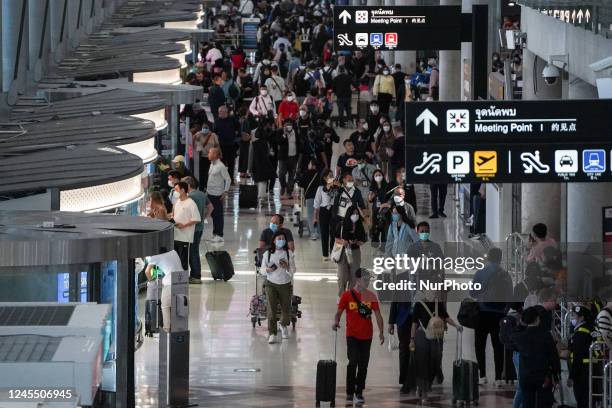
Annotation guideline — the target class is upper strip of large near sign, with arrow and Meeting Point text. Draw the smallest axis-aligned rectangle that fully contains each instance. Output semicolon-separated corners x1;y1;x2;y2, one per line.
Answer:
405;99;612;144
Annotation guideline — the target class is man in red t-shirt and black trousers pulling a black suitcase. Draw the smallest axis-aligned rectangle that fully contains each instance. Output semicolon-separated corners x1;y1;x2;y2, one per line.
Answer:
333;268;385;404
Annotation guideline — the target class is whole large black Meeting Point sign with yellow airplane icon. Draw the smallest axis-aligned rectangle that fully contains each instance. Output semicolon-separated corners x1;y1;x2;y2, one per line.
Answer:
406;100;612;183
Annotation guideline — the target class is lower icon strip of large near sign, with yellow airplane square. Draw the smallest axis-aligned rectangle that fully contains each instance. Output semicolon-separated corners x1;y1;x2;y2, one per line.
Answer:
406;142;612;184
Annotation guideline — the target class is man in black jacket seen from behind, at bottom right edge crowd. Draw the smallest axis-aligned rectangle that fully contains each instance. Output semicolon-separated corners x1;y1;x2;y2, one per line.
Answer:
512;307;561;408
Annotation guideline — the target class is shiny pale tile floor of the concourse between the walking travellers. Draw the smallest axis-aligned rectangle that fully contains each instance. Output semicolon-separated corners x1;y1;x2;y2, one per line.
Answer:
136;128;513;407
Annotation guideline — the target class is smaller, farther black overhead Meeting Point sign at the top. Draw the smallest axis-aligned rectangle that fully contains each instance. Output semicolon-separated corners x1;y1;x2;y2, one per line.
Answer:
334;5;464;51
